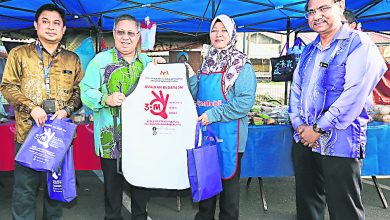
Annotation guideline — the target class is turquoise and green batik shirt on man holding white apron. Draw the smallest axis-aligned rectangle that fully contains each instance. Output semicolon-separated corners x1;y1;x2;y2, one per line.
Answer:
80;48;151;159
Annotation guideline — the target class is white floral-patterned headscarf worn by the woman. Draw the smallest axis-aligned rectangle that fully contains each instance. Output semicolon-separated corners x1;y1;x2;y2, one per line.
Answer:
200;14;250;95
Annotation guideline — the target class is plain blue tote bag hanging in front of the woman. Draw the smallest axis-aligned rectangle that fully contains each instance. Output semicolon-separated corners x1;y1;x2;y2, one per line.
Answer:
187;122;222;202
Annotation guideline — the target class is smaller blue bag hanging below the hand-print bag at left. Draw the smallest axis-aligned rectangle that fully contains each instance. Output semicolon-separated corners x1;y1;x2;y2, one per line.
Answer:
47;147;77;202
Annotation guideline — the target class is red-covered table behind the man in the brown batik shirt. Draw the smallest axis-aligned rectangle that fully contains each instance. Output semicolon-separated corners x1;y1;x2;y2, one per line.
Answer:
0;121;101;171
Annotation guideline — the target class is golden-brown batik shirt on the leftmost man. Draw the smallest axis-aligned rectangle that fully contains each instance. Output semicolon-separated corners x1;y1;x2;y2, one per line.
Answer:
0;41;84;143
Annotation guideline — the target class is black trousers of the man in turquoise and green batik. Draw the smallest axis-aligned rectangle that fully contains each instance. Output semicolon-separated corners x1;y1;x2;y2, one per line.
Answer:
100;158;150;220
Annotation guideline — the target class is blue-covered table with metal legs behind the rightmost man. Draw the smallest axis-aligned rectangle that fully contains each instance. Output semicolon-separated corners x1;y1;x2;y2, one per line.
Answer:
241;122;390;210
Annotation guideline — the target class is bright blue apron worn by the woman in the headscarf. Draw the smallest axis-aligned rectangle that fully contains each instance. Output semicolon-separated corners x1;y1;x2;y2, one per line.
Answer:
196;71;240;179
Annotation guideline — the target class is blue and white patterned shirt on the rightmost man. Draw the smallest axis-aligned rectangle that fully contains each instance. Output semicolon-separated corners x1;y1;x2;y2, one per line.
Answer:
289;26;386;158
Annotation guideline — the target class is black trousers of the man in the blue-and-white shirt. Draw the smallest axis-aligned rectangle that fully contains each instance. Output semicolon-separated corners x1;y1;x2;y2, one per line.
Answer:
292;143;365;220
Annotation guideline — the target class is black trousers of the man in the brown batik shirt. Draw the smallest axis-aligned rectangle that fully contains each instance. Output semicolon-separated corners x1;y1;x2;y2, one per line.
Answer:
12;143;62;220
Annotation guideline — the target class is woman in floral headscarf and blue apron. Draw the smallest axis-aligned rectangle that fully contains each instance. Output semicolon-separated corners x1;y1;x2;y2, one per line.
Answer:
185;15;256;220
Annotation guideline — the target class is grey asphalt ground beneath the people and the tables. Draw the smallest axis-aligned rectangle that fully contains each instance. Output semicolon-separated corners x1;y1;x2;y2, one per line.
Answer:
0;171;390;220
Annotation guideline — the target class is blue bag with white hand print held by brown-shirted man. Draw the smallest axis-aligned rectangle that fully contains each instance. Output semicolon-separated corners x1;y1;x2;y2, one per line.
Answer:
15;116;76;171
